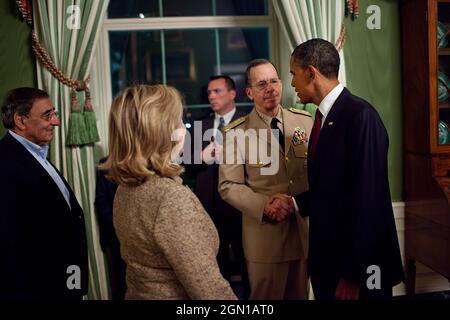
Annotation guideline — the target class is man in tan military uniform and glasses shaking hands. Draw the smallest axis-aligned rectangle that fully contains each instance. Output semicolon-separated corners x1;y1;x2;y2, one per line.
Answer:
219;59;312;299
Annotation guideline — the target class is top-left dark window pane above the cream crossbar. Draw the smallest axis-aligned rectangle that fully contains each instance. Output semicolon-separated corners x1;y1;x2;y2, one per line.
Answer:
108;0;159;19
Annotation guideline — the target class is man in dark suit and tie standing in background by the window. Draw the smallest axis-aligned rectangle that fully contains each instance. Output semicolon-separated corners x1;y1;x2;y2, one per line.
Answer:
185;75;249;295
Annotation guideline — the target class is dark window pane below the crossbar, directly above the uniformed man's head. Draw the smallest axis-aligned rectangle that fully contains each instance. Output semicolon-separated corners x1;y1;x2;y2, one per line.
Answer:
219;28;270;102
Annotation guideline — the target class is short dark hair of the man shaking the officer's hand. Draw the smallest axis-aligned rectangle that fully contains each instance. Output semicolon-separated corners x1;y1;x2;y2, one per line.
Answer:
291;39;340;79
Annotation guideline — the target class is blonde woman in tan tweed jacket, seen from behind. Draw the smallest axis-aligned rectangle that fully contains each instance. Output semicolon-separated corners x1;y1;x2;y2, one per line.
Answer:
102;85;236;299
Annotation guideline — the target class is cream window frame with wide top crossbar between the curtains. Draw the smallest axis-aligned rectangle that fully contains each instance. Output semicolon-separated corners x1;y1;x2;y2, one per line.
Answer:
90;0;280;155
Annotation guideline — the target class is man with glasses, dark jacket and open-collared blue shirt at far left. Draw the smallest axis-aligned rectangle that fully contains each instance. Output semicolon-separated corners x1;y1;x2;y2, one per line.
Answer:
0;88;88;299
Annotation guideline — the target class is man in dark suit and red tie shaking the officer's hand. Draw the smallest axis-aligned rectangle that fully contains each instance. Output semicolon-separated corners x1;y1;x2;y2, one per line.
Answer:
290;39;403;299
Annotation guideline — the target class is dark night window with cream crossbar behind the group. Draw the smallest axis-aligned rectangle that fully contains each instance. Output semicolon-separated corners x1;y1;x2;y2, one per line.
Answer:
105;0;273;119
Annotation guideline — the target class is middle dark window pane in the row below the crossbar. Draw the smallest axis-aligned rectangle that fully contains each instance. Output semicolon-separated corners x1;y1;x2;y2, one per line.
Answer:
164;30;216;105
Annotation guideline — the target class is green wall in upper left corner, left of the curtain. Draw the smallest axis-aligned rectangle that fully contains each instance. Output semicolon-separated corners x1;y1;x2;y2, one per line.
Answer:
0;0;37;137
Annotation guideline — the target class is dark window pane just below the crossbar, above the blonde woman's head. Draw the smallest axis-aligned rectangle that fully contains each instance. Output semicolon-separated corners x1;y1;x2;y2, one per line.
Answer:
109;31;163;96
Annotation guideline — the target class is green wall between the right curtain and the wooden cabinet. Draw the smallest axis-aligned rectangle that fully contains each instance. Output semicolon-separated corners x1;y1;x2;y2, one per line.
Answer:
344;0;403;201
